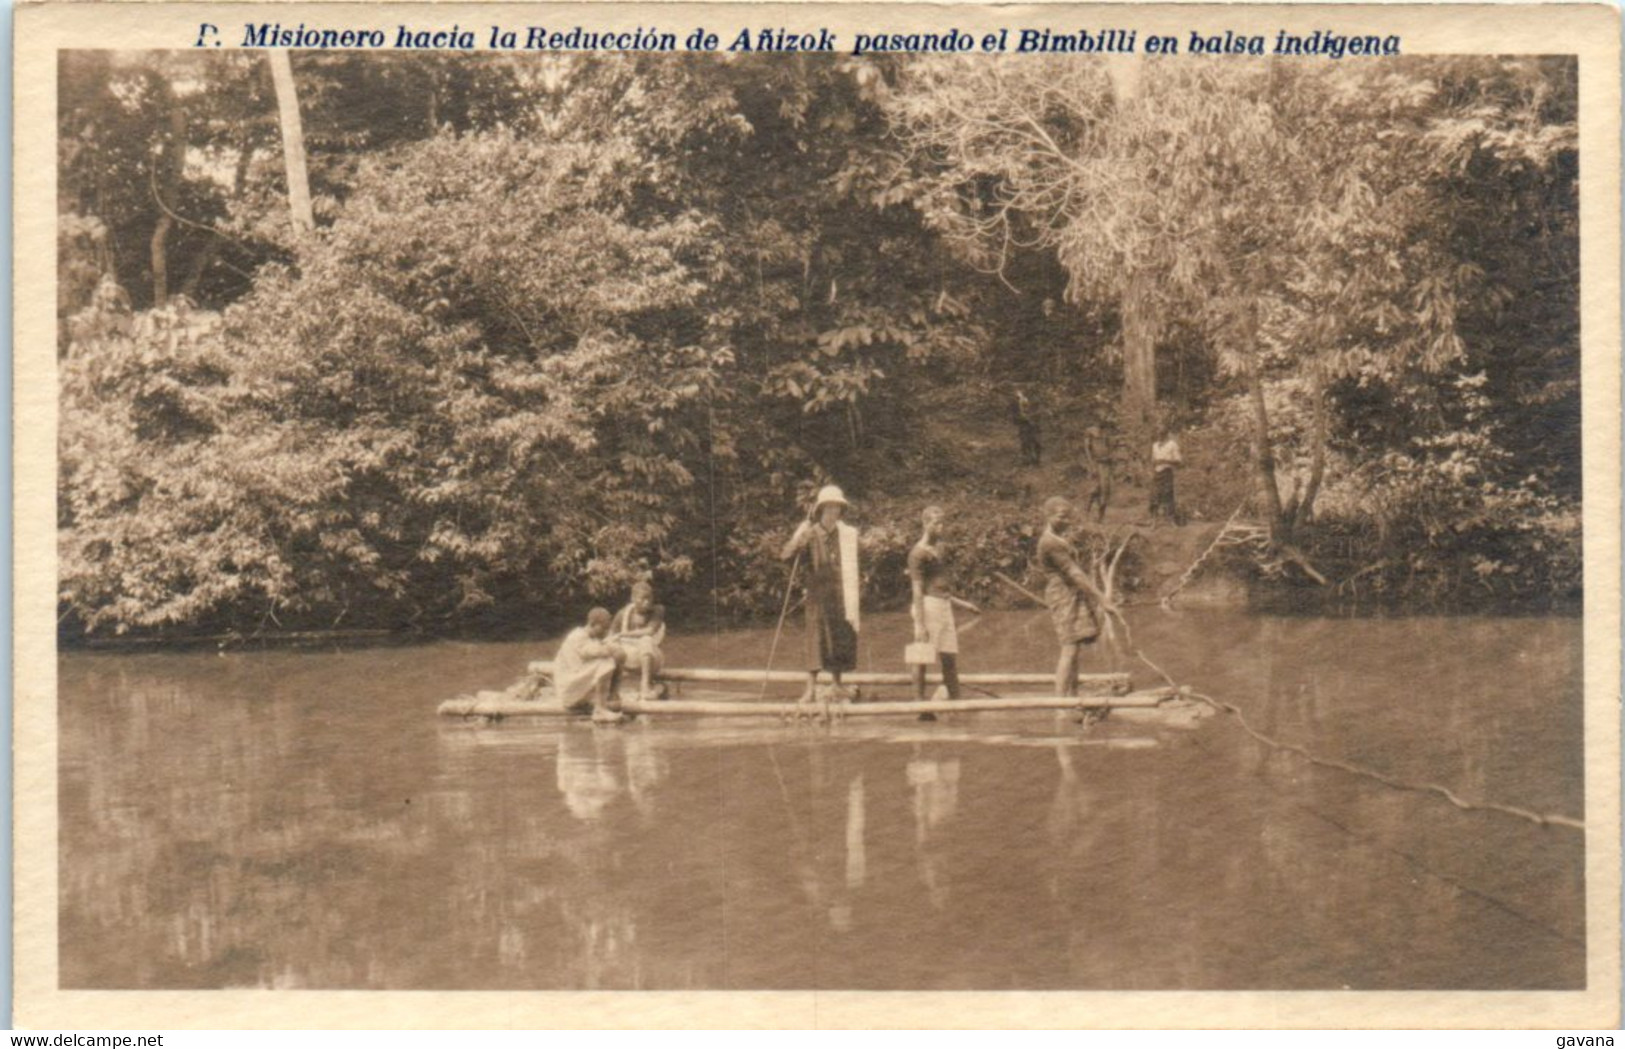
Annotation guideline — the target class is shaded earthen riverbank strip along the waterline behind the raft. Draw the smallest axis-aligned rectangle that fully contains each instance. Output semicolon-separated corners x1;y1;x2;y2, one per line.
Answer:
59;383;1581;651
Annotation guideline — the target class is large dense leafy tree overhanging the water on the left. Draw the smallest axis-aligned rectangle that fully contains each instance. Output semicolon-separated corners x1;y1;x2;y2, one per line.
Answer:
65;57;988;627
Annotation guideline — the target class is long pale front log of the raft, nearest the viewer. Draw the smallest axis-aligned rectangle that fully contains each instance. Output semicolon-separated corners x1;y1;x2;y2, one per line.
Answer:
440;689;1177;718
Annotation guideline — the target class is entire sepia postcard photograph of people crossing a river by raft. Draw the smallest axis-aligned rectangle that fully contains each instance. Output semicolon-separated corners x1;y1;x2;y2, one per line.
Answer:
16;5;1619;1026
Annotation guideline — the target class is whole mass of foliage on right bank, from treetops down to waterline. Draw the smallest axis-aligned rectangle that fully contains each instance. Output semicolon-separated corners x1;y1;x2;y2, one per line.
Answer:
892;58;1580;596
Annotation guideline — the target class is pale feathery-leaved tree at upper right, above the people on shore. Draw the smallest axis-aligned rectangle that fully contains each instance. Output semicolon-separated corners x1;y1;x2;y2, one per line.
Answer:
891;57;1573;574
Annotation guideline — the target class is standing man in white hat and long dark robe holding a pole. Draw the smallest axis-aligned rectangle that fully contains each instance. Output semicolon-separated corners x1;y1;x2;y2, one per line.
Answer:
778;484;858;700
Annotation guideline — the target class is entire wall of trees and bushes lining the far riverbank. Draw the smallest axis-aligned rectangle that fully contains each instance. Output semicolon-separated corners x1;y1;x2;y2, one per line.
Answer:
57;52;1581;646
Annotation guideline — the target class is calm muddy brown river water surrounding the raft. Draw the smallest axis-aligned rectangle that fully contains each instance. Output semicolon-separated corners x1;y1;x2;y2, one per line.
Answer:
59;611;1584;989
